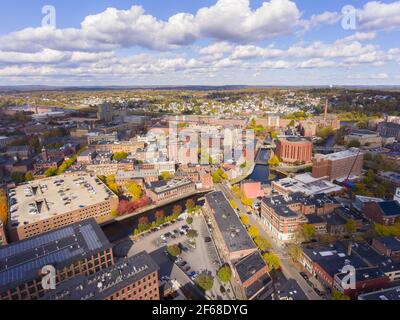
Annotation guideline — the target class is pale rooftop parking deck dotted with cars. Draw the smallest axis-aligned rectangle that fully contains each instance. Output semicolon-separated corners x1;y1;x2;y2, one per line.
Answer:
9;174;117;229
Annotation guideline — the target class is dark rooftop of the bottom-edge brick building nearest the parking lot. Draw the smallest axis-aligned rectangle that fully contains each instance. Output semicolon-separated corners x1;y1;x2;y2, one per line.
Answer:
42;252;159;301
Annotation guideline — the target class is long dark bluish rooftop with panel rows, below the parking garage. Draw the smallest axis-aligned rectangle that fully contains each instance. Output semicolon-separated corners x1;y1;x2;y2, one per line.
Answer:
0;219;112;292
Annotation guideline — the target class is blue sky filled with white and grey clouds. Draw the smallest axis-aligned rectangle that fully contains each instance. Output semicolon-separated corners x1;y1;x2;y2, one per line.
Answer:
0;0;400;85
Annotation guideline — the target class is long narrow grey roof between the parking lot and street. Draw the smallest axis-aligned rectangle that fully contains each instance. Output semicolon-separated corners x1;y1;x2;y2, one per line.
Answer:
205;191;256;252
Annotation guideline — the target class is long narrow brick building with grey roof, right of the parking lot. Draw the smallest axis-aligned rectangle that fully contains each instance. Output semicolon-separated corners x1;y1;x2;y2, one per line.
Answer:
204;191;257;263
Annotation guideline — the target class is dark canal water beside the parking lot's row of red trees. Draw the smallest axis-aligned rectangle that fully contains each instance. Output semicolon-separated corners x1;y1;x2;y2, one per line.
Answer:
102;194;204;242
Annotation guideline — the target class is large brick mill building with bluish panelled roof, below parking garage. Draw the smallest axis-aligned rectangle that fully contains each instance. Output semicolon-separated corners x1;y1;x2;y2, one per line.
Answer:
0;219;114;300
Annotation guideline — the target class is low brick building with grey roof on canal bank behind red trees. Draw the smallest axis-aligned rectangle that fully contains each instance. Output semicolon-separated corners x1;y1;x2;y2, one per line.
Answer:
146;179;196;202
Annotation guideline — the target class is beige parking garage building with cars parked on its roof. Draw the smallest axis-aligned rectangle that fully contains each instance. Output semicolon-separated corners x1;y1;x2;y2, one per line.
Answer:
8;174;119;241
